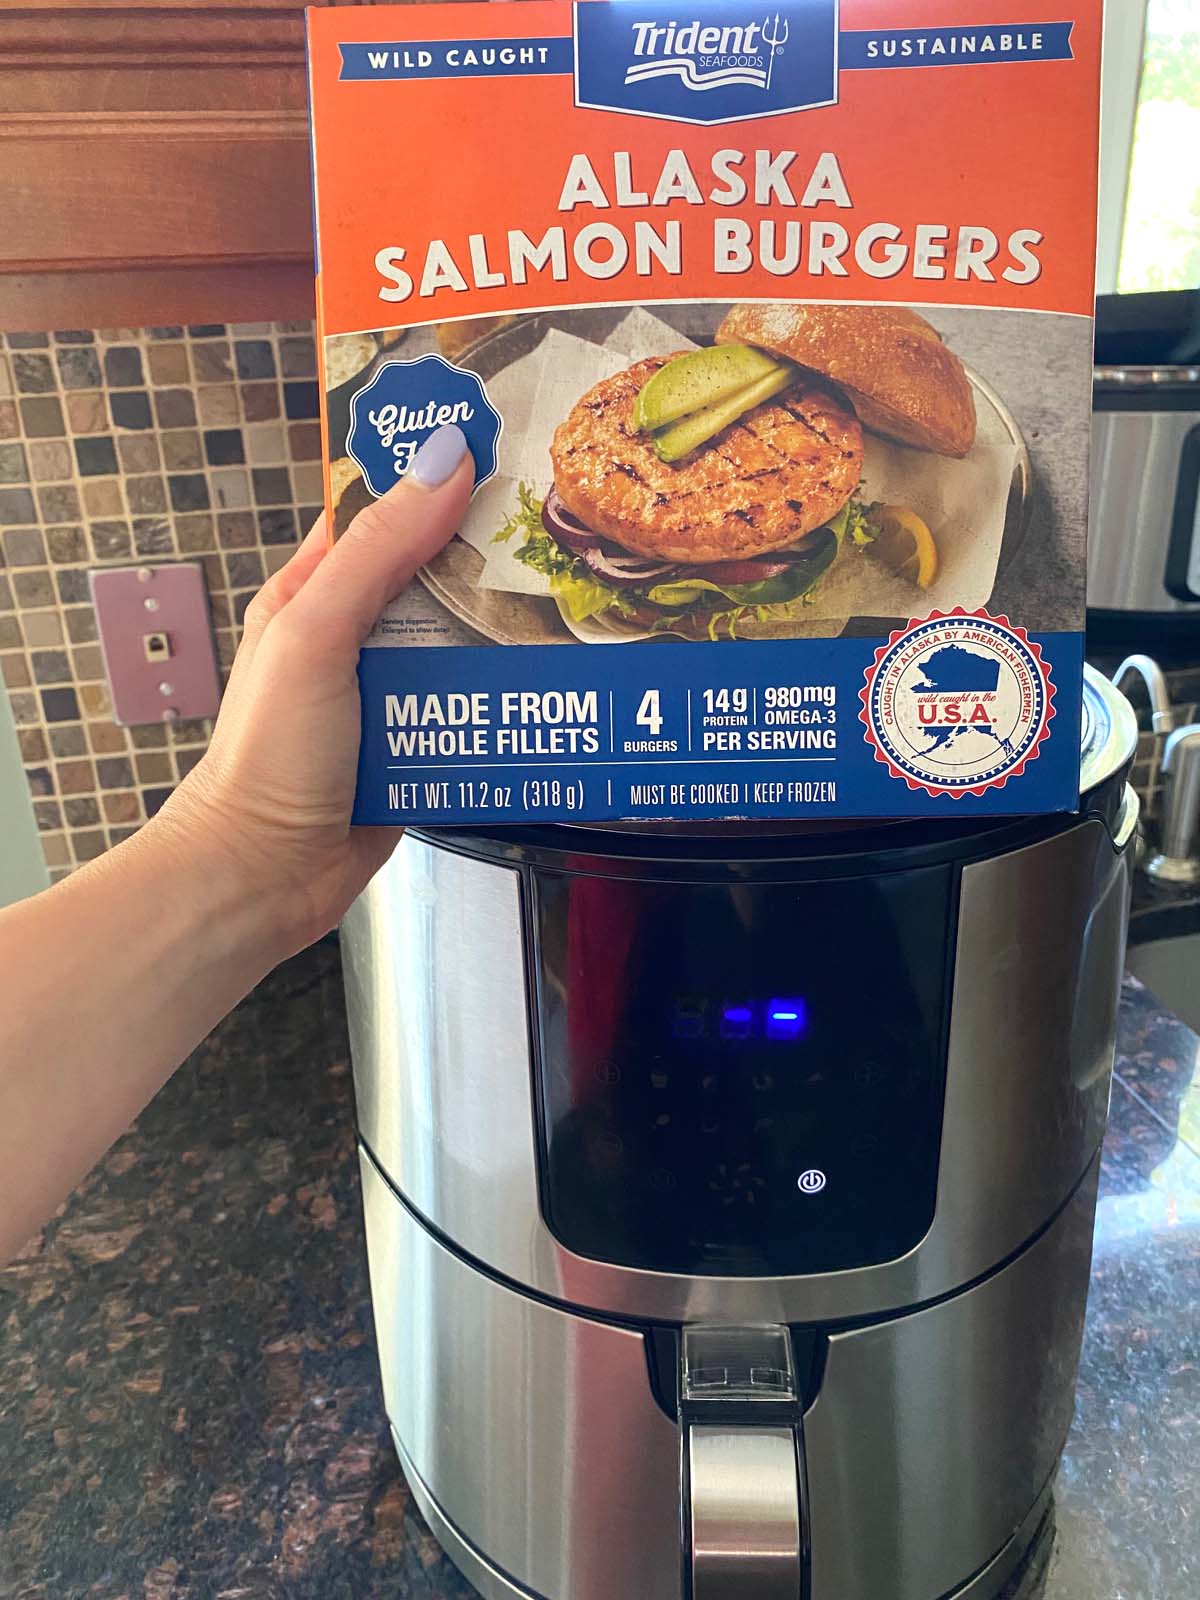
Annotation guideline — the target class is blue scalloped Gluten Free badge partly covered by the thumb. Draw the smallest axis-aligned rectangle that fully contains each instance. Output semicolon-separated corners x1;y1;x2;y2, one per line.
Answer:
346;355;504;494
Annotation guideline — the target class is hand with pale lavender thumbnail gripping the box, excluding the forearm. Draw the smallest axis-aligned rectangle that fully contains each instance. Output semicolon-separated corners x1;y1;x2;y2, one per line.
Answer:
155;424;474;958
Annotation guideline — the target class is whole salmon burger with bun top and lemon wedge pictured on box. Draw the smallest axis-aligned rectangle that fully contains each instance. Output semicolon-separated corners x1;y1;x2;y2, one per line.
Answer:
498;304;976;638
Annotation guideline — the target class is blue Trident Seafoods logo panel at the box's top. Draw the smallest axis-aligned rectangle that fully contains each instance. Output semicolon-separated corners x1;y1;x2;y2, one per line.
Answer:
574;0;837;123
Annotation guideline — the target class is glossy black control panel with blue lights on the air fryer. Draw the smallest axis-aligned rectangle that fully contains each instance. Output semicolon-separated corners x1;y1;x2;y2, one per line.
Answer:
533;866;954;1275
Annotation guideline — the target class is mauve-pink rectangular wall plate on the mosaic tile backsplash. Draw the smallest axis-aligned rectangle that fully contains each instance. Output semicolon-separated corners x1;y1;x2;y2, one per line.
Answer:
88;562;221;726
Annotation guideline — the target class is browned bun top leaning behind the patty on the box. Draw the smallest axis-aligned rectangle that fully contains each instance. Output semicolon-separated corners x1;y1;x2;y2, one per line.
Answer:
717;306;976;456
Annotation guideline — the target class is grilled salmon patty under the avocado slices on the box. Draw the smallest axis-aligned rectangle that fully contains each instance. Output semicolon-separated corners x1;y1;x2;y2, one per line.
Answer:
550;355;862;563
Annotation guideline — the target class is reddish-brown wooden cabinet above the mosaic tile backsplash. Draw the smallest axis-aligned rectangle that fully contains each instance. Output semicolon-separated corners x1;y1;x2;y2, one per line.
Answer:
0;0;370;330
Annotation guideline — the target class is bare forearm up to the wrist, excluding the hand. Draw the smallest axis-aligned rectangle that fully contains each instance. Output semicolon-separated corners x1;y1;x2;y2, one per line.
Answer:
0;819;286;1262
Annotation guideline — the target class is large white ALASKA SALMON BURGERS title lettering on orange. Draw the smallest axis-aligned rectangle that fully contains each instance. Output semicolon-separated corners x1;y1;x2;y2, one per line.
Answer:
374;149;1043;304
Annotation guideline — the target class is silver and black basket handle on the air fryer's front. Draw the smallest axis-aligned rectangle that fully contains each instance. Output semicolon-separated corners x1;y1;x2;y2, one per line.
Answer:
680;1326;806;1600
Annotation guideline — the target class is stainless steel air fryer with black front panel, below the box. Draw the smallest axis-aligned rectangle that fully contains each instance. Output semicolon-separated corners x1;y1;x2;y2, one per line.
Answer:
342;662;1136;1600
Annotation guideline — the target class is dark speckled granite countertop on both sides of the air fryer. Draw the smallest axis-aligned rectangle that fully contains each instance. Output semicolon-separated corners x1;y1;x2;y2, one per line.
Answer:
0;942;1200;1600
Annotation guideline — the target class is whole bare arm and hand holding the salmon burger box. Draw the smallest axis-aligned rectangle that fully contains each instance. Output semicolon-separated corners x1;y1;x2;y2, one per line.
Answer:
0;438;475;1262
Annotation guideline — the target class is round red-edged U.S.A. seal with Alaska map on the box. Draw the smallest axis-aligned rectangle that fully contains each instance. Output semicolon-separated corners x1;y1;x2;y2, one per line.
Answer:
859;610;1054;795
